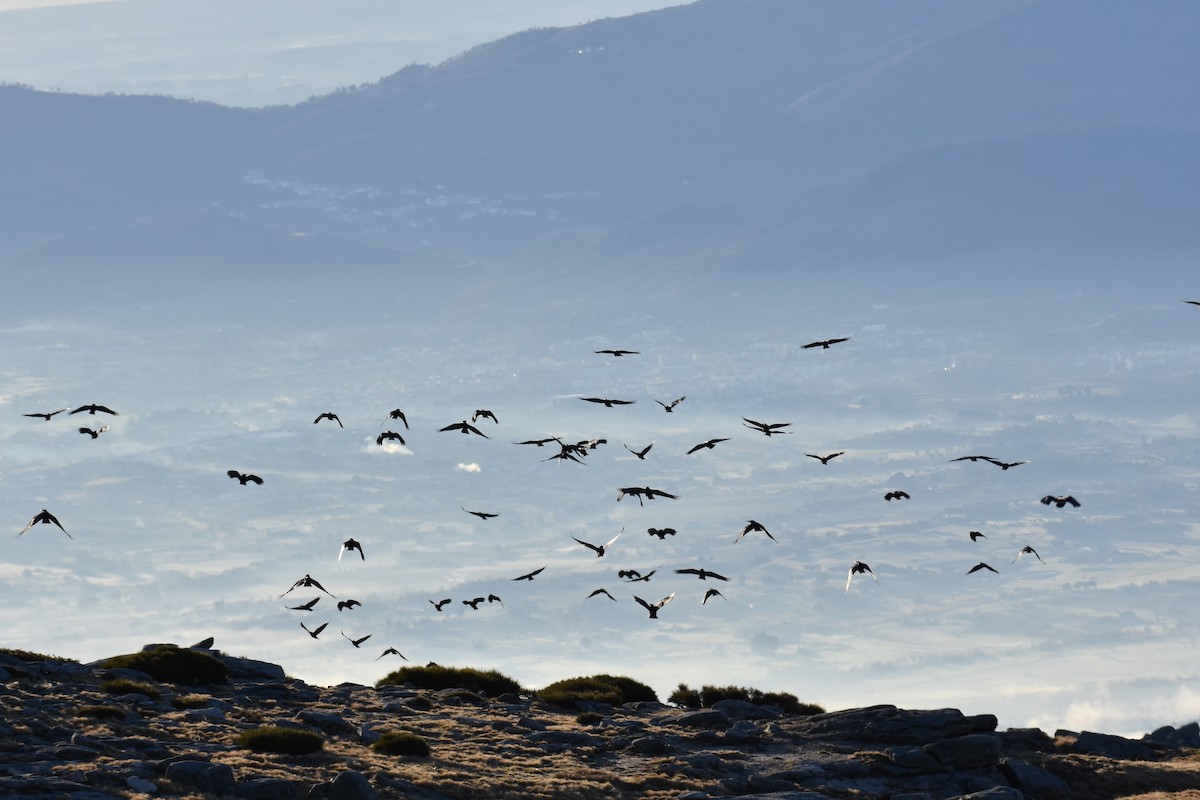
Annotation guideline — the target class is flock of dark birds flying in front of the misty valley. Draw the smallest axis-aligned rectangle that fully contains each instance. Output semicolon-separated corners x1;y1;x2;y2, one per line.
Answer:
18;328;1099;661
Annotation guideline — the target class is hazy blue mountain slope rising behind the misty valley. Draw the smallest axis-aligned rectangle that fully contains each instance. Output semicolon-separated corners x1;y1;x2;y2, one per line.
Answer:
0;0;1200;319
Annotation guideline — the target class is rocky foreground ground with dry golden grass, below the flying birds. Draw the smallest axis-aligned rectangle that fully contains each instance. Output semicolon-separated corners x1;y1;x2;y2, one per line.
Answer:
0;650;1200;800
